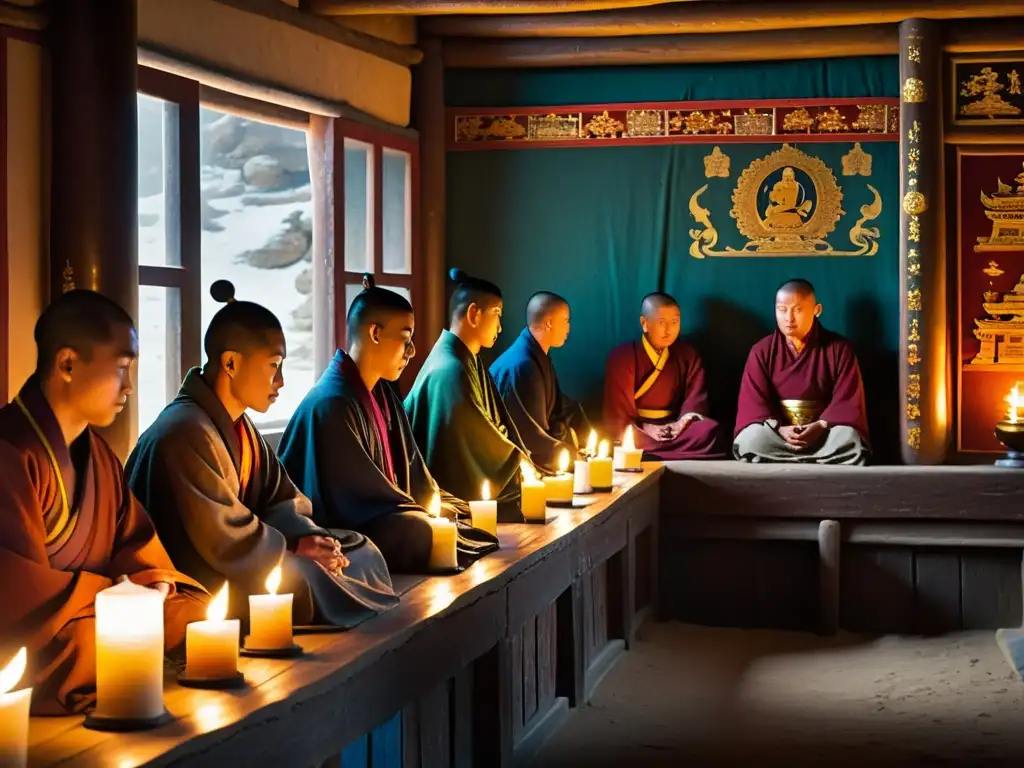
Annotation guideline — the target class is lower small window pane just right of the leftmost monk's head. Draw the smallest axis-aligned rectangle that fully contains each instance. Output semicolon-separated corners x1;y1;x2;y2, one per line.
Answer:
135;286;181;434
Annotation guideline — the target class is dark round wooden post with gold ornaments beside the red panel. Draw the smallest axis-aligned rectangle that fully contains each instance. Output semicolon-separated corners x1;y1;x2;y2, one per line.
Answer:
899;18;951;464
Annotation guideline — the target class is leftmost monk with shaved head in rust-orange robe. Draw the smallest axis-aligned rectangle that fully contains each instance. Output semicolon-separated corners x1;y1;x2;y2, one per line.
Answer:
0;291;209;715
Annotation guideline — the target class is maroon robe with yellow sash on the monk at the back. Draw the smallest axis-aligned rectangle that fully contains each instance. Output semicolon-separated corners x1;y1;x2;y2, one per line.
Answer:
604;339;726;461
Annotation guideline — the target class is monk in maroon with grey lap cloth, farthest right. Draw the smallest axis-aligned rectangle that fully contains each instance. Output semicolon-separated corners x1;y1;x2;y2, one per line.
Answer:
732;280;868;464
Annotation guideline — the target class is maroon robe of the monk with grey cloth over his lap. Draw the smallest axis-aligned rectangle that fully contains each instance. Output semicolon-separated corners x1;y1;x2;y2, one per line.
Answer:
734;321;867;445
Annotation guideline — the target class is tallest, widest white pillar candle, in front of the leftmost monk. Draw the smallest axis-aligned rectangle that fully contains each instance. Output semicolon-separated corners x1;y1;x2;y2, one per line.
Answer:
95;579;164;720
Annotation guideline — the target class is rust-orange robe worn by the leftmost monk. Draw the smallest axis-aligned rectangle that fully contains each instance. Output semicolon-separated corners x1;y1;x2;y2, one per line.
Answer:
0;377;209;715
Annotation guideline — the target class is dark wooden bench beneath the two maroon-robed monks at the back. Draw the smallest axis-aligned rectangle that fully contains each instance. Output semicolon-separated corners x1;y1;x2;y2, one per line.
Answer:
660;462;1024;634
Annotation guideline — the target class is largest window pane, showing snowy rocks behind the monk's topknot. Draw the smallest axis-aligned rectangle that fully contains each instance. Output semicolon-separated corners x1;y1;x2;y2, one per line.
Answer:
200;108;313;426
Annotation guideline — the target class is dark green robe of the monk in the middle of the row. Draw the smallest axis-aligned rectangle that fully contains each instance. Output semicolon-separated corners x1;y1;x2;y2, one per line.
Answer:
404;331;528;522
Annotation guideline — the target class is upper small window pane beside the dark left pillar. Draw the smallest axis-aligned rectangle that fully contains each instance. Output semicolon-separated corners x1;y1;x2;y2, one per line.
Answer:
137;93;181;266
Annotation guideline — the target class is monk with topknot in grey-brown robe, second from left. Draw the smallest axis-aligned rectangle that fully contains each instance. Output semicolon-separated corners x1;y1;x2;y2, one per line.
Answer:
126;281;397;628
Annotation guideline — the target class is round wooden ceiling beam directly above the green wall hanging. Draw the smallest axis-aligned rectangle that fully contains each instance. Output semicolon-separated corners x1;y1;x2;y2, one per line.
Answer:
444;25;899;69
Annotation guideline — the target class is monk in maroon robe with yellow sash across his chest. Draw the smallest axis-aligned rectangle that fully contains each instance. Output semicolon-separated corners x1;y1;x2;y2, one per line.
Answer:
604;293;726;461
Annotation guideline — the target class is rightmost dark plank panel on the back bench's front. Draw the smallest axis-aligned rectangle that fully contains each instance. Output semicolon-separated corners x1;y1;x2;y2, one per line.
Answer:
961;550;1022;630
